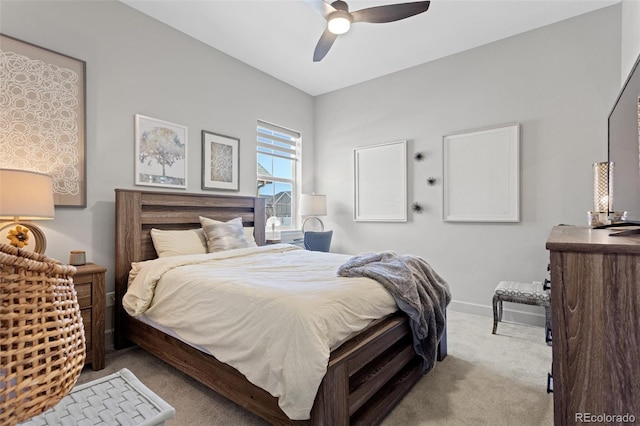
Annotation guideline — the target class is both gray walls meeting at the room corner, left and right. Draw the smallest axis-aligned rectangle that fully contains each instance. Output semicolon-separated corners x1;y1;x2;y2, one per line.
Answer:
0;1;632;332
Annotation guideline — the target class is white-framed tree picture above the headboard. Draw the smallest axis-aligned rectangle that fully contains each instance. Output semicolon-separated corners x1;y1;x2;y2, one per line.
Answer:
135;114;187;189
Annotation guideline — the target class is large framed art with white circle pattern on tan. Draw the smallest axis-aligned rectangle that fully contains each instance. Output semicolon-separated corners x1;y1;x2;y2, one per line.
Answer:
0;34;87;207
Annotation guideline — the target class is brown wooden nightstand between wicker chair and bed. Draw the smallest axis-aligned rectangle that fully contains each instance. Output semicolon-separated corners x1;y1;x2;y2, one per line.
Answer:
73;263;107;370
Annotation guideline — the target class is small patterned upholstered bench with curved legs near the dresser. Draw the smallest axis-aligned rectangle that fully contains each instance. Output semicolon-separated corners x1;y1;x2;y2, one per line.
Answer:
492;281;551;343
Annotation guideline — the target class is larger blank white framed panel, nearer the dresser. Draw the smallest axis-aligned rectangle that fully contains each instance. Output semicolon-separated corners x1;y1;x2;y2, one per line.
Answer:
443;123;520;222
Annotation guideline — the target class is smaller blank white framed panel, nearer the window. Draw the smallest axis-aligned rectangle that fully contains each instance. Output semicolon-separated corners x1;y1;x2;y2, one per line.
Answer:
353;140;407;222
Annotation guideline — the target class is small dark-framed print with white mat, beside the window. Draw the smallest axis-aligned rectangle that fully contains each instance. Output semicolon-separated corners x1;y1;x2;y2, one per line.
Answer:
202;130;240;191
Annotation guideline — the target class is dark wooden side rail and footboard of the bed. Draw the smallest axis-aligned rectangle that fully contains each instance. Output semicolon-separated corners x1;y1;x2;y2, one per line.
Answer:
125;313;446;426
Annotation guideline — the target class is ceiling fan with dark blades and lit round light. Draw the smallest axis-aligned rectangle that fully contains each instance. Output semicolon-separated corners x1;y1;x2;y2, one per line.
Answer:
304;0;431;62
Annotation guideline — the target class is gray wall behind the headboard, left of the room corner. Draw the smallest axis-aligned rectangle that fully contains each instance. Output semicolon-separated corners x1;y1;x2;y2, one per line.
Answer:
0;1;314;340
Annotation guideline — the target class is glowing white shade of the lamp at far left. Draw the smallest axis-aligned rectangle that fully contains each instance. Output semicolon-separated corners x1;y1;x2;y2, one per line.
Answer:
0;169;55;220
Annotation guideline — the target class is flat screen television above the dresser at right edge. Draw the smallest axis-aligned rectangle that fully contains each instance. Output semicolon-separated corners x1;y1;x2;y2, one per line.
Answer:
609;57;640;231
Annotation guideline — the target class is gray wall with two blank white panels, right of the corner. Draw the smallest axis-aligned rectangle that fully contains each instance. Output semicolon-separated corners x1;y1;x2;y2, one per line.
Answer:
315;5;621;324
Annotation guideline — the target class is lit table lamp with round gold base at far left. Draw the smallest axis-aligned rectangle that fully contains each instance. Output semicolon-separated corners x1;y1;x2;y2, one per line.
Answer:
0;169;54;254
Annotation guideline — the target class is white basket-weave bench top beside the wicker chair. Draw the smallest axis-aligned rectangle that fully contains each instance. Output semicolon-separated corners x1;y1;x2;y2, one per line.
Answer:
21;368;175;426
